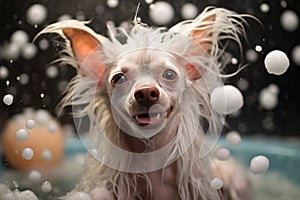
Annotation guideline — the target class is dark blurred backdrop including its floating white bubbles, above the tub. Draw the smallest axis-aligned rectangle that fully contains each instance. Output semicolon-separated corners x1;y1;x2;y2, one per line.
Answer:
0;0;300;137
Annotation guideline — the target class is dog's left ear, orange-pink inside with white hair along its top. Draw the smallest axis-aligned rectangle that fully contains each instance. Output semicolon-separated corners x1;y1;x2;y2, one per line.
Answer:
37;20;108;80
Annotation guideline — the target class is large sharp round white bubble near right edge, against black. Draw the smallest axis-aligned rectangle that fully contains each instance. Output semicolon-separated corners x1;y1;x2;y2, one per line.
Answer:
264;50;290;75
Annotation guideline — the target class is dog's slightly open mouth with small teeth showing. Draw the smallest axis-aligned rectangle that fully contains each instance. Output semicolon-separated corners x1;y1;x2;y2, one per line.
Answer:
133;106;173;126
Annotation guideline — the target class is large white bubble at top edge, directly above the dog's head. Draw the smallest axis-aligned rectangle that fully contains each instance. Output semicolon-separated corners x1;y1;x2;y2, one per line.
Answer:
149;1;175;25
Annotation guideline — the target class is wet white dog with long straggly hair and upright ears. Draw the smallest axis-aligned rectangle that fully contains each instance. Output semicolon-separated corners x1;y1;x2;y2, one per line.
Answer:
39;7;250;200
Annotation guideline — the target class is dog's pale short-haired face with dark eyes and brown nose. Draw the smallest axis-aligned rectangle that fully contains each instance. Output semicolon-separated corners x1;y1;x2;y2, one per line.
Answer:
107;48;186;138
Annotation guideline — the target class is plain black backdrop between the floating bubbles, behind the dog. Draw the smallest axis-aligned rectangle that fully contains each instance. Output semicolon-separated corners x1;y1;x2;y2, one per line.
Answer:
0;0;300;136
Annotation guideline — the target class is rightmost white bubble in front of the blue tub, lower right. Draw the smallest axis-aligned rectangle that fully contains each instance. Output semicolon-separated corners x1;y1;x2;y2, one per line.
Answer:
250;155;270;175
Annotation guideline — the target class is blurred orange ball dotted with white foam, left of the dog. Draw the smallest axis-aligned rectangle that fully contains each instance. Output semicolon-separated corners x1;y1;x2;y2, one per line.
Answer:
1;111;64;169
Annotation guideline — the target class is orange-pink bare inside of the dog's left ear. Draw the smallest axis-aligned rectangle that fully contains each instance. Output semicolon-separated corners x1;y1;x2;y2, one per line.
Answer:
63;28;106;79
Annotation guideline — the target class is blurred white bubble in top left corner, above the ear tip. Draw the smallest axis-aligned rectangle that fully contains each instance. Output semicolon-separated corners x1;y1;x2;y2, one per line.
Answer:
26;4;47;25
